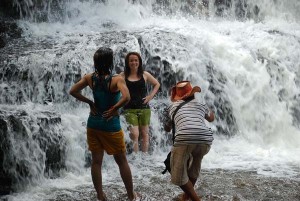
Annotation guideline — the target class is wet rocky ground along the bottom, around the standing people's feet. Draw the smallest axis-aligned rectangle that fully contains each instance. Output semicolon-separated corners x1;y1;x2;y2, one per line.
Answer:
29;169;300;201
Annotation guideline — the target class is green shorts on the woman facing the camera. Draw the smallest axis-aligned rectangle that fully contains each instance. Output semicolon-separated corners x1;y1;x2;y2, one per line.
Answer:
124;108;151;126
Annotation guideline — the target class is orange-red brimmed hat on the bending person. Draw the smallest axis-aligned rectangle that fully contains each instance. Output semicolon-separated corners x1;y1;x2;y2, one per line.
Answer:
171;81;201;102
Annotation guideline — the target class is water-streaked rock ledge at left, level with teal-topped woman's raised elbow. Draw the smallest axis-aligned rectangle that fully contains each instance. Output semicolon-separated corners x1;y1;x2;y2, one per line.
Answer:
0;55;81;104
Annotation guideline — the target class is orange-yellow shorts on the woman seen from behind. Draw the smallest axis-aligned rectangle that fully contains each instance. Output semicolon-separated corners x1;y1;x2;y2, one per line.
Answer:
87;128;126;155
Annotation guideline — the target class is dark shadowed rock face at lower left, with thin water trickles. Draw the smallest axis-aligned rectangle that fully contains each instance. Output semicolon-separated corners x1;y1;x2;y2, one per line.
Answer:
0;110;66;195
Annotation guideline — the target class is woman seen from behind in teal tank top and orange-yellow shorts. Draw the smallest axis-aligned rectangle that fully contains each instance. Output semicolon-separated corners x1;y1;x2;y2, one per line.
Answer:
70;48;137;201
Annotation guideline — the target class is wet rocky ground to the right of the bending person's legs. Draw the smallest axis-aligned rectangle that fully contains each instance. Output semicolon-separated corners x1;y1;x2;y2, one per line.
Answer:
198;170;300;201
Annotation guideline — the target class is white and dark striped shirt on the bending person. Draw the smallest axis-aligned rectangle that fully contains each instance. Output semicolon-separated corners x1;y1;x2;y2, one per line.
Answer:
165;99;214;146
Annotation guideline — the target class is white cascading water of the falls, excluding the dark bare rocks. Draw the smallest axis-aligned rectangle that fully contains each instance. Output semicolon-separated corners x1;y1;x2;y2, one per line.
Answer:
0;0;300;200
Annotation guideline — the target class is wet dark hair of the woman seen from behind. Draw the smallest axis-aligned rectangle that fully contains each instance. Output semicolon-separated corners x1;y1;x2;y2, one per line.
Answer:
94;47;113;75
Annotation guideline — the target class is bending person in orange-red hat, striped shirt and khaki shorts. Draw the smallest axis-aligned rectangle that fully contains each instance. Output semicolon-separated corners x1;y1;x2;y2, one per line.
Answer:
164;81;214;201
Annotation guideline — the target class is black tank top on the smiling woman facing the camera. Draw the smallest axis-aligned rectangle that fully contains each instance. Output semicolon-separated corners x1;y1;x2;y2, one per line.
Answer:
124;76;150;109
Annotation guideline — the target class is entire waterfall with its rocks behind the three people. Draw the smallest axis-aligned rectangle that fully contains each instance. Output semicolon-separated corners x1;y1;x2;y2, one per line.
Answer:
0;0;300;199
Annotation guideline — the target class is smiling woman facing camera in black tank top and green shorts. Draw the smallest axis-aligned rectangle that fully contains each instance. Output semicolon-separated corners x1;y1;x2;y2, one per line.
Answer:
121;52;160;153
